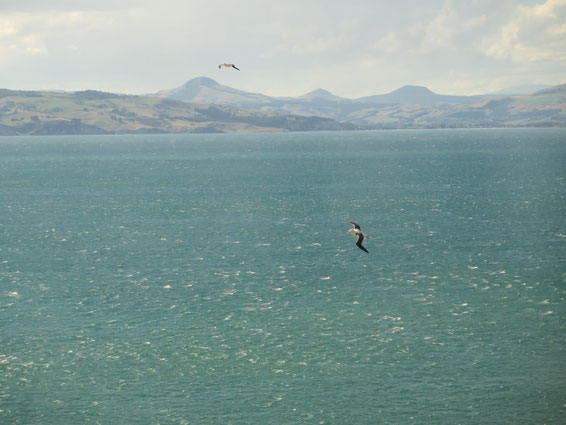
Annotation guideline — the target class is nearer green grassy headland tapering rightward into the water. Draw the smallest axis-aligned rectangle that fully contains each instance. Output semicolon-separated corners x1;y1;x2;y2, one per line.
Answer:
0;89;360;135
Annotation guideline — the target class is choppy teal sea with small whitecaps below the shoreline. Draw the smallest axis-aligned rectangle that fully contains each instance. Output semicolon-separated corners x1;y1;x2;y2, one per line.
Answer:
0;129;566;425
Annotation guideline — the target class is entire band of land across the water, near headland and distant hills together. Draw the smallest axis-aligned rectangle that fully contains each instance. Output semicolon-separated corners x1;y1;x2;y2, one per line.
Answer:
0;77;566;135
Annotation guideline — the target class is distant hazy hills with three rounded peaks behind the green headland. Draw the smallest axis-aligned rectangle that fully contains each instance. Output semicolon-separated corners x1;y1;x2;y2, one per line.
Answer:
151;77;566;128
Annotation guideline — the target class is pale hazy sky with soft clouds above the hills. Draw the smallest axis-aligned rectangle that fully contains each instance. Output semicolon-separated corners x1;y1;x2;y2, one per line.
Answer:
0;0;566;98
